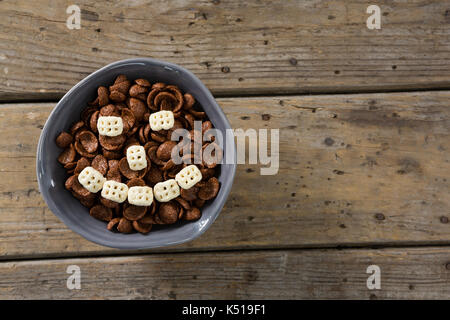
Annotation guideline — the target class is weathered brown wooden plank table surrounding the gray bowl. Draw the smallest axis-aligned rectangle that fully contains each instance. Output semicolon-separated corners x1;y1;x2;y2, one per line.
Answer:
0;0;450;299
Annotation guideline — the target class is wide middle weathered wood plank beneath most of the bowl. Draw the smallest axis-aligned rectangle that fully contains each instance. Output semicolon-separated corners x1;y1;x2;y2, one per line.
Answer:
0;91;450;258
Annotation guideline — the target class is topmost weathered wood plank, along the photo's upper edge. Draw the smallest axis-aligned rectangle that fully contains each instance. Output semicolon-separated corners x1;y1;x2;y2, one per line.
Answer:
0;0;450;101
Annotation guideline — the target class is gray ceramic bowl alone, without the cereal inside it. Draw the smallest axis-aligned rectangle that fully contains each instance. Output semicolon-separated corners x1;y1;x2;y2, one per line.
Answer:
36;58;236;249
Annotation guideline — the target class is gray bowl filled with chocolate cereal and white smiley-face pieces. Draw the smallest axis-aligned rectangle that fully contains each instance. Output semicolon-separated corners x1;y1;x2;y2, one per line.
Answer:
36;58;236;249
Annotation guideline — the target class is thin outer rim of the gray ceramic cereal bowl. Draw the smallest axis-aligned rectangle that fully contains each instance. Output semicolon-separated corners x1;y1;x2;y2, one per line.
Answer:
36;58;237;250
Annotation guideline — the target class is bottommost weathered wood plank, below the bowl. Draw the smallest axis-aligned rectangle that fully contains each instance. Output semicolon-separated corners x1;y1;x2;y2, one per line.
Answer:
0;247;450;300
